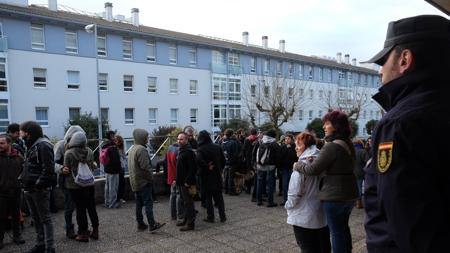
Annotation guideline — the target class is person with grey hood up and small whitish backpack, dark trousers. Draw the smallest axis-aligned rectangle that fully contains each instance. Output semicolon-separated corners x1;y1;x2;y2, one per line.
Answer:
62;131;99;242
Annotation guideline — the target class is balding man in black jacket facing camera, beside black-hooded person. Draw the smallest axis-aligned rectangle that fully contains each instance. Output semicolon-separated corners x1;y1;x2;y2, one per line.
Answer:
176;132;197;231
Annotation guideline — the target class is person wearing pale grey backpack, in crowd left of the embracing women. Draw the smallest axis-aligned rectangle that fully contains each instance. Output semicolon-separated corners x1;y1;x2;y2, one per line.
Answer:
254;129;281;207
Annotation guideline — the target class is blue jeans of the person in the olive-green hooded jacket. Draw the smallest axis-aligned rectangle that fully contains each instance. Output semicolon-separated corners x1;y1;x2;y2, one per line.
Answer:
134;184;155;226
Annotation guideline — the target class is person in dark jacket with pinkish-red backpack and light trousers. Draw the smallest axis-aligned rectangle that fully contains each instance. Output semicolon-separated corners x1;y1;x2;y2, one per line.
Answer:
100;131;122;208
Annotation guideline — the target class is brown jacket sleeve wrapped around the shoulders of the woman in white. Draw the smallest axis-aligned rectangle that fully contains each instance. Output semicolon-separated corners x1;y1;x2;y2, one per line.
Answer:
294;143;336;176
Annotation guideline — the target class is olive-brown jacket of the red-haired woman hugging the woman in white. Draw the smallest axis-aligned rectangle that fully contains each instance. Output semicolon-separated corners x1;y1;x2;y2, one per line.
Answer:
294;142;359;201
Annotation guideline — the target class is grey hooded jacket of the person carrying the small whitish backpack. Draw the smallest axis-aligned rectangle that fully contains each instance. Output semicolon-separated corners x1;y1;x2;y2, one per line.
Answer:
64;131;96;189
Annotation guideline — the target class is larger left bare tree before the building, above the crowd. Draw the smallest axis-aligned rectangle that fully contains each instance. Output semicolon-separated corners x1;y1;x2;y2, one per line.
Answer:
242;75;309;136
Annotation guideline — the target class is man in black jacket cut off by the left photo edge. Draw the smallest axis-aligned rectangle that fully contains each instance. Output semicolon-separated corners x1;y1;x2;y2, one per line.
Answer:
0;134;25;249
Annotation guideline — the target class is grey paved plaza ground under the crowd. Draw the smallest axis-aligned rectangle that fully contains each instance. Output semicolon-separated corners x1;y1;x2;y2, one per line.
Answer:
0;194;366;253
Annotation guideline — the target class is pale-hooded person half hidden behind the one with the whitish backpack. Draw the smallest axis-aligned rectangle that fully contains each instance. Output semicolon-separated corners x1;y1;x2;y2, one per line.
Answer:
53;125;85;239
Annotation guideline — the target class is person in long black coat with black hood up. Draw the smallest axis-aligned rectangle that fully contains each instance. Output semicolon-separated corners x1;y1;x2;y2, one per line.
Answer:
196;130;226;223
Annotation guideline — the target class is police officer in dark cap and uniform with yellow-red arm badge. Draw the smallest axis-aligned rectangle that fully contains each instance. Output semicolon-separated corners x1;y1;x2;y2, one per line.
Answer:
364;15;450;253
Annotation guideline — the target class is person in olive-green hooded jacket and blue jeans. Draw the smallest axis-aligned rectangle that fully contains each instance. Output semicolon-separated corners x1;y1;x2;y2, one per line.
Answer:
128;128;165;231
